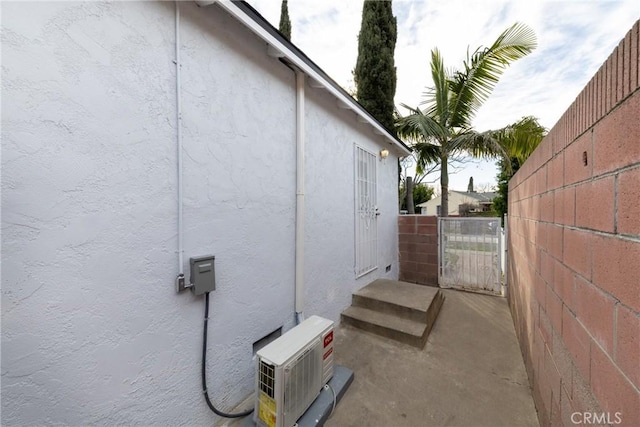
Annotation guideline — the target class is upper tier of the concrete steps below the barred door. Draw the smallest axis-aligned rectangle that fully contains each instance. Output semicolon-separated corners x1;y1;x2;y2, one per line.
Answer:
351;279;442;323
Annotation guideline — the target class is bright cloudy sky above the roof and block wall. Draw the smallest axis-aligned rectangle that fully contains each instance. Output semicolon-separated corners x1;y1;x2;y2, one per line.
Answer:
248;0;640;190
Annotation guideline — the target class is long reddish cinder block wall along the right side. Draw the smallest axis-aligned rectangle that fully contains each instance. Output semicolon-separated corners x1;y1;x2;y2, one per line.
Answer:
508;22;640;426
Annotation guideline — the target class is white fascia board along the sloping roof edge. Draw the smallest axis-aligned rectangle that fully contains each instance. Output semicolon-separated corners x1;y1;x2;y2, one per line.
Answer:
196;0;411;156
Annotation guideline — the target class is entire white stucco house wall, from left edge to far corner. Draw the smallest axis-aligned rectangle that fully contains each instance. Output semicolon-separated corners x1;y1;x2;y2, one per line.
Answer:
1;2;398;426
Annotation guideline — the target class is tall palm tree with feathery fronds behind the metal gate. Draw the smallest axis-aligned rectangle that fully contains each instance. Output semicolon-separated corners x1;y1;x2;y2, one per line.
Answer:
396;23;536;216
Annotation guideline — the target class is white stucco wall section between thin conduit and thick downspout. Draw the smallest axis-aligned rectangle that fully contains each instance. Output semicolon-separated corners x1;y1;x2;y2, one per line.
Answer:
175;3;296;411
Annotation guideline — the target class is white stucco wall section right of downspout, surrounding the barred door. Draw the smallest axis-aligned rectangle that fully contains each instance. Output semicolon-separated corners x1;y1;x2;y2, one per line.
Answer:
305;86;398;321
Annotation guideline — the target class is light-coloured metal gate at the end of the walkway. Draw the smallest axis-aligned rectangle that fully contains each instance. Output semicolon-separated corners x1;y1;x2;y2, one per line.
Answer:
438;218;502;295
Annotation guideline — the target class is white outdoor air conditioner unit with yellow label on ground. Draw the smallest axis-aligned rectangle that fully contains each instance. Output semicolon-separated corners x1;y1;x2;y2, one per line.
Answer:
254;316;333;427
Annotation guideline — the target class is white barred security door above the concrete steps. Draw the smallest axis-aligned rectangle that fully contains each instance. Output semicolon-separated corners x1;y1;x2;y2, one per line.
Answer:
355;147;378;277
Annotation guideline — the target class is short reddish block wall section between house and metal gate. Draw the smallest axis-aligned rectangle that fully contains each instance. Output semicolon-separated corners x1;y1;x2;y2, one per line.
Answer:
398;215;438;286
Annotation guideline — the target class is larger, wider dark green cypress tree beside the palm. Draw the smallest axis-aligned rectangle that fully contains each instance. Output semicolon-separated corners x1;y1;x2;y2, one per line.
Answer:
353;0;397;134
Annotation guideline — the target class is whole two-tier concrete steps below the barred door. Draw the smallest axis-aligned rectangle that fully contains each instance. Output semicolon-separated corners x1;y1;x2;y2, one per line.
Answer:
341;279;444;348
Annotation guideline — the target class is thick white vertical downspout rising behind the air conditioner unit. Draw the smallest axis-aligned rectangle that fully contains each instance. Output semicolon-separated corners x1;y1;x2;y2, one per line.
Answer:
295;70;305;323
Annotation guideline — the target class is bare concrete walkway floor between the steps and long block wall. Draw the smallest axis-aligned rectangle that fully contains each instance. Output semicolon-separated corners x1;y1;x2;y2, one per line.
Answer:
325;290;538;427
